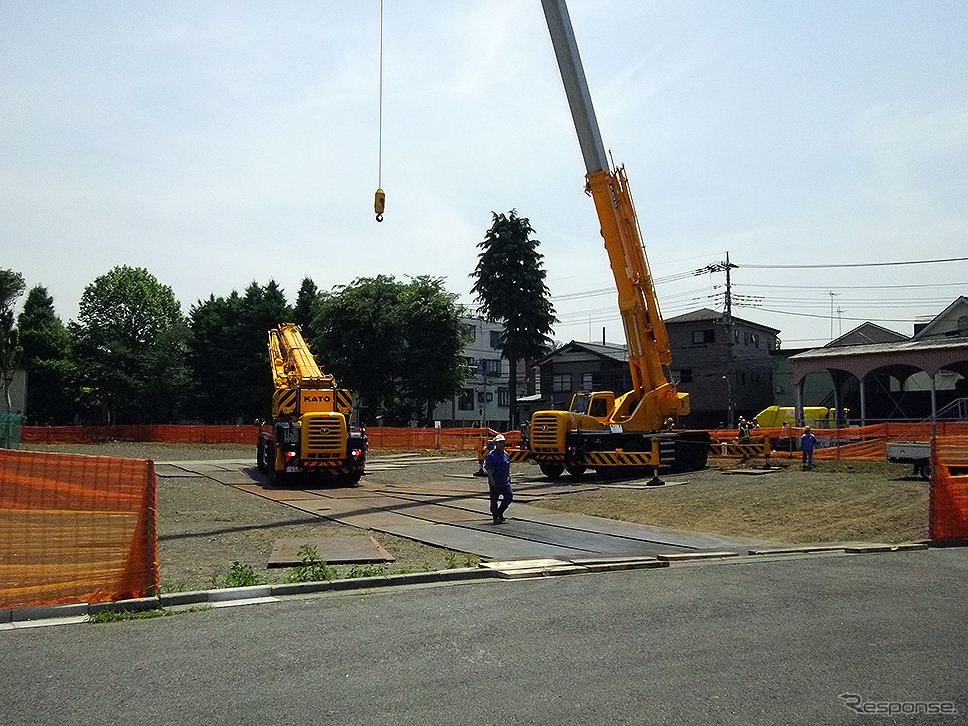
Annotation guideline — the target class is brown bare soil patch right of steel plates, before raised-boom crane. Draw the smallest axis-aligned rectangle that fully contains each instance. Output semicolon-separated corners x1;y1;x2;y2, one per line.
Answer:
541;460;929;544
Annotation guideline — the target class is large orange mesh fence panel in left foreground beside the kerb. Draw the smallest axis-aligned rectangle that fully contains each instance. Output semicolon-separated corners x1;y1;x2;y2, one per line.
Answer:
0;450;158;608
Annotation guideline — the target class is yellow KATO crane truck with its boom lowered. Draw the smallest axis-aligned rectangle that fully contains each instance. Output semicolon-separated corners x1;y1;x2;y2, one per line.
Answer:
257;323;366;486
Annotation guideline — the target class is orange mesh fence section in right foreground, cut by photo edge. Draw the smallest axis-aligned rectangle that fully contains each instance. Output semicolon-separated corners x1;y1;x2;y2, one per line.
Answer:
929;436;968;540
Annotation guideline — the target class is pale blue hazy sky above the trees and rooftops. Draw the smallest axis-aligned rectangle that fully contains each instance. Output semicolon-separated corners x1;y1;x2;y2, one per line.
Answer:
0;0;968;347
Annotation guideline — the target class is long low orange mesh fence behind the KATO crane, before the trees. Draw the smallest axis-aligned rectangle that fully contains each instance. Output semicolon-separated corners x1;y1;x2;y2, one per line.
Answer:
20;424;500;451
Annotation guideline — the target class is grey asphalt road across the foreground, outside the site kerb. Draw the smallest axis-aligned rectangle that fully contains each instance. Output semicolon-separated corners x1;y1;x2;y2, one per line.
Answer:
0;549;968;726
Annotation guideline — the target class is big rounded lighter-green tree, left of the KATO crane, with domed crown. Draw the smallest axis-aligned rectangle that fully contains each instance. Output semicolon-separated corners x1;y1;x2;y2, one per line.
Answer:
71;266;188;423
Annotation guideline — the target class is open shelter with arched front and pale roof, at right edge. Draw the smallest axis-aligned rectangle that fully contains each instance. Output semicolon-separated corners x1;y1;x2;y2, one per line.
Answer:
790;337;968;426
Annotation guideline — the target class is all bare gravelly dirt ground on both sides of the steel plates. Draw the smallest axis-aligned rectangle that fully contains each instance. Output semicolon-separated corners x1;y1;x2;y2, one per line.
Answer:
25;442;928;592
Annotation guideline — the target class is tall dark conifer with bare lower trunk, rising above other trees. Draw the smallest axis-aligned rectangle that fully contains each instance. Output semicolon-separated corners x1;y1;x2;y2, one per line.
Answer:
471;209;558;428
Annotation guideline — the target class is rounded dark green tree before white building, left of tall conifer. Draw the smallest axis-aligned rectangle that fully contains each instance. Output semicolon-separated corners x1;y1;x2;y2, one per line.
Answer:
398;276;469;426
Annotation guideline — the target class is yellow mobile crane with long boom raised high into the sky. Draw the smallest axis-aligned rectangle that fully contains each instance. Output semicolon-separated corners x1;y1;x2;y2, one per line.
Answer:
522;0;709;479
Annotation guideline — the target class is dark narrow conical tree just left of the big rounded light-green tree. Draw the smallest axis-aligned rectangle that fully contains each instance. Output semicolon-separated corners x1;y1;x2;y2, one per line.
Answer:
17;285;76;425
